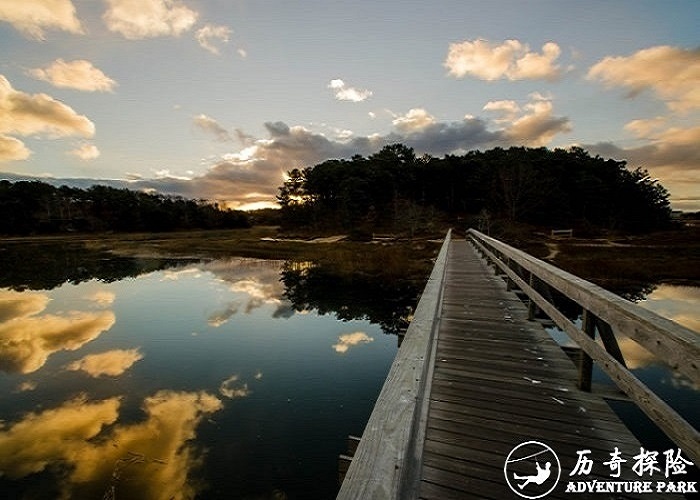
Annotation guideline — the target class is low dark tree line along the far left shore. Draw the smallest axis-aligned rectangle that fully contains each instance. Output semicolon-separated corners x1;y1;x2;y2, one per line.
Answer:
0;180;249;235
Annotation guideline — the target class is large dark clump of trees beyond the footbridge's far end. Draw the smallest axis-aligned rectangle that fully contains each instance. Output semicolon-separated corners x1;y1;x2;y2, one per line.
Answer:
277;144;671;232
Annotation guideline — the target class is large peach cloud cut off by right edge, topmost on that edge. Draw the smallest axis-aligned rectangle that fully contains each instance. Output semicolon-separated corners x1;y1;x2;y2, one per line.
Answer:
588;45;700;112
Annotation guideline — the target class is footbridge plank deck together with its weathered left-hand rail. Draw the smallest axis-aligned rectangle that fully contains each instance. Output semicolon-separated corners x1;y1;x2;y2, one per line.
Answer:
338;235;683;500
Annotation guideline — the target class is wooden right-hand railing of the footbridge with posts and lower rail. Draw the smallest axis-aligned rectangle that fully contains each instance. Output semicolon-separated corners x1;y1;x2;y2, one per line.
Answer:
467;229;700;464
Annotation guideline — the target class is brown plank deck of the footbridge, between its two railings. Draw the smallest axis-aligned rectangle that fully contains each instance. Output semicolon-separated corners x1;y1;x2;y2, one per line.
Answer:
414;240;668;500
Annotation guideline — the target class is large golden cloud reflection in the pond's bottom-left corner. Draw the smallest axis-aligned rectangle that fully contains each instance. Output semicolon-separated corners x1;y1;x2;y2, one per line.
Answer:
0;391;223;500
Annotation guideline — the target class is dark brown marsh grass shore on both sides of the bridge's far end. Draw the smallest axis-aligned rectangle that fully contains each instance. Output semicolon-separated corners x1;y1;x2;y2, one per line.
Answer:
0;226;700;288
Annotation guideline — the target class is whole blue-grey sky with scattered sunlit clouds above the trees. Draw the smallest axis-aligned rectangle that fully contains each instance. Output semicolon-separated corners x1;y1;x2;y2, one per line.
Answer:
0;0;700;210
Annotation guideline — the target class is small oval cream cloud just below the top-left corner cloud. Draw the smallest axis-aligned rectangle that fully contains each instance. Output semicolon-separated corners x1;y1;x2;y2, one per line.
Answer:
29;59;117;92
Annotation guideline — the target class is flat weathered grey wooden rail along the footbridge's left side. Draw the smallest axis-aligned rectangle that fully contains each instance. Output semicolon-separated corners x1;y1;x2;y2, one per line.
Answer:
337;232;451;500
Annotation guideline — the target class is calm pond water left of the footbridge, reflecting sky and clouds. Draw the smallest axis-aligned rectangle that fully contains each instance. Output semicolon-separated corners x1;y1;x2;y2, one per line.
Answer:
0;259;415;499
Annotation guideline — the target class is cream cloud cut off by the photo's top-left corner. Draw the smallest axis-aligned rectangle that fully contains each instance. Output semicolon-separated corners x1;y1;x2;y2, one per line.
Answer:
0;0;83;40
